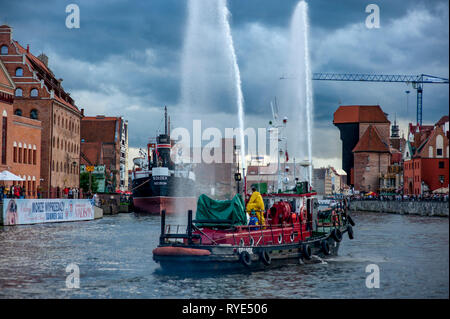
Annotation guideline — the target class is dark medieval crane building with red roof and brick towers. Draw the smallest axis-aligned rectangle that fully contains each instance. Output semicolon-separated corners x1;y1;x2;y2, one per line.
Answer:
333;105;390;186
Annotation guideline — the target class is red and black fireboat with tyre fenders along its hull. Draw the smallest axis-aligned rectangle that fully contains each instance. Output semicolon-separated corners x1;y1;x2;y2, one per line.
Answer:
153;189;354;272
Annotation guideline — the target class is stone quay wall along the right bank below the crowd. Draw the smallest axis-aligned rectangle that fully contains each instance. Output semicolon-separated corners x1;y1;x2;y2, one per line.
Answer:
350;200;449;217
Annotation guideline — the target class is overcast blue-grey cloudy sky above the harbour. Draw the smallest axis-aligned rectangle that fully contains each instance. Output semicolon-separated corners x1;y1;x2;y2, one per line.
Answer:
0;0;449;167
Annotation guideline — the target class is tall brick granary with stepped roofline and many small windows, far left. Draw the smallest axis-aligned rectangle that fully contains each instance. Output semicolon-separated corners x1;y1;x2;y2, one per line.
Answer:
0;25;82;197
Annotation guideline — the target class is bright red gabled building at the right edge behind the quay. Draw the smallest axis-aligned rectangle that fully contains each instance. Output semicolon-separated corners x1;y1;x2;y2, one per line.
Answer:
403;116;449;195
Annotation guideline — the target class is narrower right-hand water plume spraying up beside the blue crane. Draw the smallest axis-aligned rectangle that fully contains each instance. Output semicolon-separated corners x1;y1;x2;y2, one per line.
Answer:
280;0;313;183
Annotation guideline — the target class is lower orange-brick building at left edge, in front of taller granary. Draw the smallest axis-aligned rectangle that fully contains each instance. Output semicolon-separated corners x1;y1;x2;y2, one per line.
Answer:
0;60;41;197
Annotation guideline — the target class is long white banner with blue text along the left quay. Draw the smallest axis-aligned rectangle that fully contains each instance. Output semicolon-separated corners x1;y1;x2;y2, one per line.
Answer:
3;198;94;225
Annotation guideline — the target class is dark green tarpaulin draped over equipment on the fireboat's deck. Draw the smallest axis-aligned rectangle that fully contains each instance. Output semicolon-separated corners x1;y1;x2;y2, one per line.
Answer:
195;194;247;226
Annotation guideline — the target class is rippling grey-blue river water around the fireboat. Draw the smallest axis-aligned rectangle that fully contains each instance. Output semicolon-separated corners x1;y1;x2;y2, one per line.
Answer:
0;212;449;298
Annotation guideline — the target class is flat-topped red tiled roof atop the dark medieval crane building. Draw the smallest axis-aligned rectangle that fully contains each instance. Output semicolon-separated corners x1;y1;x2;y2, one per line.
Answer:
333;105;389;124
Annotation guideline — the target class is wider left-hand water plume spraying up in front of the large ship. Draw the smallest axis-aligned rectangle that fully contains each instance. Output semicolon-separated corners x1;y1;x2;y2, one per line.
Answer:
179;0;245;205
